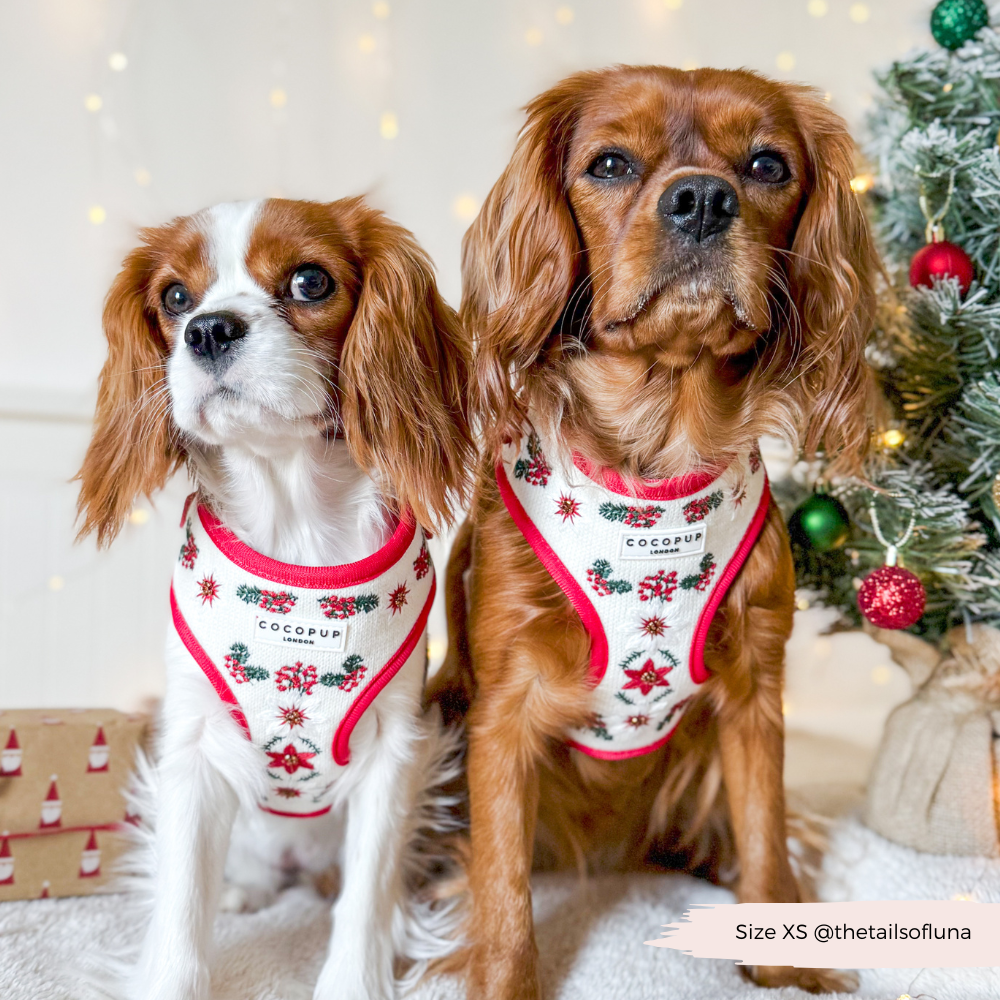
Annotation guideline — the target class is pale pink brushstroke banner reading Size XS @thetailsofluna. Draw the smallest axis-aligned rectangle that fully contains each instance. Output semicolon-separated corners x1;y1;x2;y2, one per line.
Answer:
645;900;1000;969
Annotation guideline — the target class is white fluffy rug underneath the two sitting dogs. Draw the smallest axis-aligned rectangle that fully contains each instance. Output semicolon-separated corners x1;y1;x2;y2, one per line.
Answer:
0;822;1000;1000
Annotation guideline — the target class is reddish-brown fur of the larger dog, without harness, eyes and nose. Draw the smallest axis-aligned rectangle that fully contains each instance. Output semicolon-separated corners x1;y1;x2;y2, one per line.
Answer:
431;67;878;1000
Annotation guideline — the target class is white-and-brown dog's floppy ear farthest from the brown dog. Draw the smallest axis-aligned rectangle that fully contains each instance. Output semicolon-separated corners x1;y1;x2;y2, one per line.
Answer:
76;234;184;546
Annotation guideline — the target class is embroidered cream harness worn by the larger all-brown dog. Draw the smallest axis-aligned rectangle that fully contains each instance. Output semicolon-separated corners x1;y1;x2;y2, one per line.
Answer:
497;430;770;760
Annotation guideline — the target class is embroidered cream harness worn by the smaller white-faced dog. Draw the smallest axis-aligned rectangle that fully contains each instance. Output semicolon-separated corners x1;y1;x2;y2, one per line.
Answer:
170;498;435;816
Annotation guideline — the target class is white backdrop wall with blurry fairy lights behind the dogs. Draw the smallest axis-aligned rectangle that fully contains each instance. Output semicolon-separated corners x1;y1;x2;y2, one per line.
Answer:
0;0;931;734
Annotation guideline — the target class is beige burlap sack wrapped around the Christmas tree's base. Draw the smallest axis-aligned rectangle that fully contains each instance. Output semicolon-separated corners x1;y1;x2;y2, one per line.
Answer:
866;625;1000;858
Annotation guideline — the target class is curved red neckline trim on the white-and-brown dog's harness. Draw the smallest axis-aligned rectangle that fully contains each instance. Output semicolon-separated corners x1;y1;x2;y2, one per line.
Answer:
198;504;417;590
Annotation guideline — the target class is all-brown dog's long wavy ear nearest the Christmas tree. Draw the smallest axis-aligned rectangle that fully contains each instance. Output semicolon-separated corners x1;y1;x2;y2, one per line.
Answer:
789;88;881;473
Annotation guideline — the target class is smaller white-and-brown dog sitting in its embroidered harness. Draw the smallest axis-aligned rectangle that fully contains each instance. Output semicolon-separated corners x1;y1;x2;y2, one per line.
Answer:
79;199;474;1000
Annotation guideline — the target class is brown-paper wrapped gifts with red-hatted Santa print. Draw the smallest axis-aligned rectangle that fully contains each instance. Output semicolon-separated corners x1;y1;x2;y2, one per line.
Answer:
0;708;149;901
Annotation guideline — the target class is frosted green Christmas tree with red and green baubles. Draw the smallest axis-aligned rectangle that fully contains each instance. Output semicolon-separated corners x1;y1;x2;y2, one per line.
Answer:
777;0;1000;639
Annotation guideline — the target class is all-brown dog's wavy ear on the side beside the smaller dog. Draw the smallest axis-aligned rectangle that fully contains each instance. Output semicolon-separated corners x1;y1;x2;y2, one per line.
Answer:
461;77;584;458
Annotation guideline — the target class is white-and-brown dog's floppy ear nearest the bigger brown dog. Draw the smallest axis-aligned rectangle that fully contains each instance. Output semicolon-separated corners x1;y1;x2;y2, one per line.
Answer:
339;202;476;528
